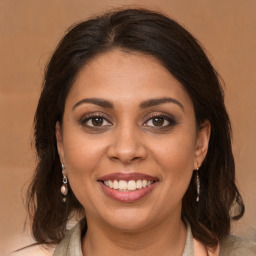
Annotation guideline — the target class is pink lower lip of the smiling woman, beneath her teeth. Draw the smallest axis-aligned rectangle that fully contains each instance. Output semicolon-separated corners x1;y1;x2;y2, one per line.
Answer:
100;182;157;203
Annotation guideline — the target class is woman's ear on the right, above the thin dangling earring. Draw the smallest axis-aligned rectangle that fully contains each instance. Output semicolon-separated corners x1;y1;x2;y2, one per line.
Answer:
194;120;211;170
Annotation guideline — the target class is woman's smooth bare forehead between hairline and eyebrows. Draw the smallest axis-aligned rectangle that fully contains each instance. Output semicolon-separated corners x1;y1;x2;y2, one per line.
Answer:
67;50;192;110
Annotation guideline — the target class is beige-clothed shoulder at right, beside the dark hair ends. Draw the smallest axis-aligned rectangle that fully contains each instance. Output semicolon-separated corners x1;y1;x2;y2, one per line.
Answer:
220;235;256;256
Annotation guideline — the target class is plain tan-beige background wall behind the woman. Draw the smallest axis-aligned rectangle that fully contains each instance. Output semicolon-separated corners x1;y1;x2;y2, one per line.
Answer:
0;0;256;255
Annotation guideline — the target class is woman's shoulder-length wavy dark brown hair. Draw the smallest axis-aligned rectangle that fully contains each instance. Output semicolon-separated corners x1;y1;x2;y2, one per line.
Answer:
27;9;244;248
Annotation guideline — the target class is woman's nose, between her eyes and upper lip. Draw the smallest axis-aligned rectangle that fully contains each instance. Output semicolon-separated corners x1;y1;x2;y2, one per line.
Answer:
108;124;147;164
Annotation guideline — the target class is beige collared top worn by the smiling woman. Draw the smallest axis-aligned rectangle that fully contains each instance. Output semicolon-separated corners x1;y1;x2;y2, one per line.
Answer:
53;221;256;256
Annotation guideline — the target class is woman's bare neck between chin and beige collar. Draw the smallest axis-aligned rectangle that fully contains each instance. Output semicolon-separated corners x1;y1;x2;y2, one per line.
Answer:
82;214;186;256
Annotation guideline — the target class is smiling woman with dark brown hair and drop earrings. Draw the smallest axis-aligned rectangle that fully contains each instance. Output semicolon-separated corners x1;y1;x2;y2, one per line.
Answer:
21;9;256;256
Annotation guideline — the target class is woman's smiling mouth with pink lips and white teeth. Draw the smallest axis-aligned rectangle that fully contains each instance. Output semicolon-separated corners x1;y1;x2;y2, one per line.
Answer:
98;173;159;202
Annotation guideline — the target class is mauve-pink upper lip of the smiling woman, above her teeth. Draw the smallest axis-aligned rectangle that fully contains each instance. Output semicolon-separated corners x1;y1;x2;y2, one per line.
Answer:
98;172;159;181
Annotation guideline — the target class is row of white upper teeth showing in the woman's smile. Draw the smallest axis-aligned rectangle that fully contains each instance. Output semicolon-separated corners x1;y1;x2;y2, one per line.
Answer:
104;180;153;191
